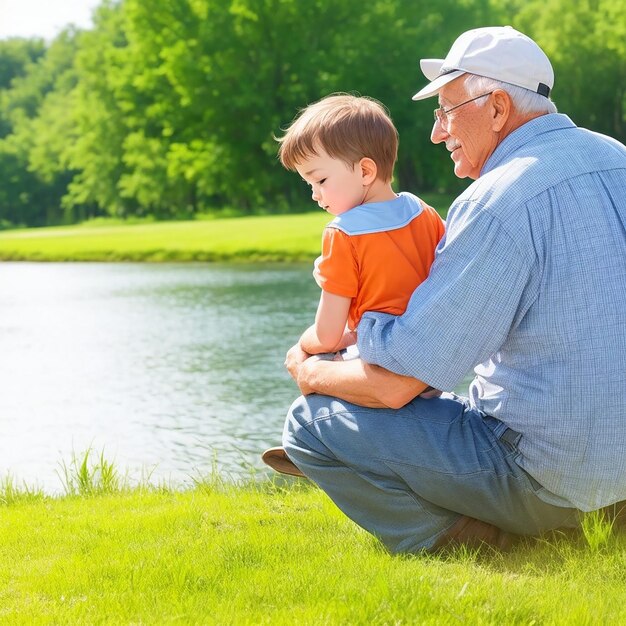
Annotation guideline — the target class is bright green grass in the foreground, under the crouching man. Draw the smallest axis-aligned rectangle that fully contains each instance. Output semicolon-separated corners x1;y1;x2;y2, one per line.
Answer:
0;455;626;625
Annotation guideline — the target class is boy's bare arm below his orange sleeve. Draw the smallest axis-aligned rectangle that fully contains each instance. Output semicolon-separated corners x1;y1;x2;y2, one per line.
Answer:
299;290;352;354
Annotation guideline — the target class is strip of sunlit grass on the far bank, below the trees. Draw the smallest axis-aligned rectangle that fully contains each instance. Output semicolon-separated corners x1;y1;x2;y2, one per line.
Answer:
0;196;450;262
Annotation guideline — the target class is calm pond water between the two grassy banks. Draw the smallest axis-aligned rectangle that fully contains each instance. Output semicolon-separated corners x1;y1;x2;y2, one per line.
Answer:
0;263;468;493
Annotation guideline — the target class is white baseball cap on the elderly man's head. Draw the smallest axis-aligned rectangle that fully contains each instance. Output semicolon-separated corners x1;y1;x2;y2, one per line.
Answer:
413;26;554;100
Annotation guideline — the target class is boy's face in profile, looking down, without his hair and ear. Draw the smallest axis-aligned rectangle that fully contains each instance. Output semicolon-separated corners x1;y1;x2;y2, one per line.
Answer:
296;150;367;215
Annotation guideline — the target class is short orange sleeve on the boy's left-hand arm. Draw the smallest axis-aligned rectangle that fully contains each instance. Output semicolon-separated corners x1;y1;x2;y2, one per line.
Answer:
313;227;359;298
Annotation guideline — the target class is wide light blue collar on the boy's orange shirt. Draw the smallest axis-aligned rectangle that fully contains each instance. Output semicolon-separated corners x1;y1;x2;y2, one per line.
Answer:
326;191;426;236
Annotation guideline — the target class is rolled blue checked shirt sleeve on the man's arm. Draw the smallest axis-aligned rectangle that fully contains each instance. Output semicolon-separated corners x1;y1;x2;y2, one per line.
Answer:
357;206;536;390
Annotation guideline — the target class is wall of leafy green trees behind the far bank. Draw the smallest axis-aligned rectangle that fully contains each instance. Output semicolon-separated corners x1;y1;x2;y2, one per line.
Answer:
0;0;626;227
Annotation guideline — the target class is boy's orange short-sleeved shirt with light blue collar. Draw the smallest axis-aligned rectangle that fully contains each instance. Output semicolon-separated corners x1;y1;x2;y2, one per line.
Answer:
313;193;444;330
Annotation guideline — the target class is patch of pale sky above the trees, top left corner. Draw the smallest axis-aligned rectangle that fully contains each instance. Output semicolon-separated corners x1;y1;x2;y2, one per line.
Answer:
0;0;100;41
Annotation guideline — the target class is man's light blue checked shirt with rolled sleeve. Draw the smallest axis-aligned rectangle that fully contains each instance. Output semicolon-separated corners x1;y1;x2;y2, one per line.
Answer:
358;114;626;510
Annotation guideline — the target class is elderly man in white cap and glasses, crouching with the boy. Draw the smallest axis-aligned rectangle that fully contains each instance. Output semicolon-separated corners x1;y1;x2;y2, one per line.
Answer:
266;27;626;552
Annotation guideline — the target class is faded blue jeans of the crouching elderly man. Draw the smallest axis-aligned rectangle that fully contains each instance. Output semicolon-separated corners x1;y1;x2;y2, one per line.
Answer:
283;394;579;552
